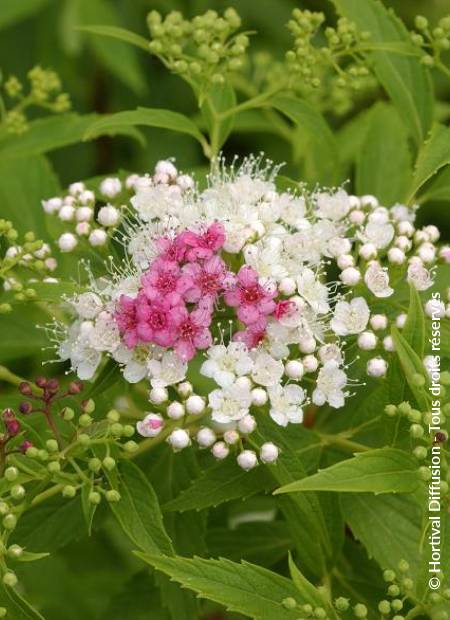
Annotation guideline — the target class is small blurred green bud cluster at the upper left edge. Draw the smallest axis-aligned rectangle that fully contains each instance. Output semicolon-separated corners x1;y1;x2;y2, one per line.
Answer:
3;66;70;134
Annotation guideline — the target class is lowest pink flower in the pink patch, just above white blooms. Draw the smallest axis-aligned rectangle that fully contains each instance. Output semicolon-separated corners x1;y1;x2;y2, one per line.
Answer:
174;304;212;362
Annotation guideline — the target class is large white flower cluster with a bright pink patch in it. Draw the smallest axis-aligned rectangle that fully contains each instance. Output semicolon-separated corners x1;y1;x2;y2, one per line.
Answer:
41;158;448;470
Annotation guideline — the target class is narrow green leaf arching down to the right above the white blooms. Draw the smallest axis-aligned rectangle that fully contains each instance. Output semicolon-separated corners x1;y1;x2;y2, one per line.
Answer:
268;95;339;184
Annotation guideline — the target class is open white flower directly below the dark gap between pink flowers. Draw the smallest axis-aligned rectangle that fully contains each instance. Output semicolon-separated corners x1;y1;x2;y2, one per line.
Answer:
200;342;253;387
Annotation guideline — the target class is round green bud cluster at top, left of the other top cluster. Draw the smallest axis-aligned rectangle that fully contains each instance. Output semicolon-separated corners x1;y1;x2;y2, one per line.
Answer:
147;8;249;88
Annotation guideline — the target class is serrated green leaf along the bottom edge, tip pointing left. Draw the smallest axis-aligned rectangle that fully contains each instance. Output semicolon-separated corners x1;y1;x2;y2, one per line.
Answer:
137;553;303;620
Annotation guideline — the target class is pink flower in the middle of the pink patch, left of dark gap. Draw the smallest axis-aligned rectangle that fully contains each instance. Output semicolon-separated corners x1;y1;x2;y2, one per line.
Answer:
183;256;227;302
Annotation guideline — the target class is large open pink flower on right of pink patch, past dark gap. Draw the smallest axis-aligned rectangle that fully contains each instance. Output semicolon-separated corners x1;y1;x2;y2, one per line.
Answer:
224;266;277;325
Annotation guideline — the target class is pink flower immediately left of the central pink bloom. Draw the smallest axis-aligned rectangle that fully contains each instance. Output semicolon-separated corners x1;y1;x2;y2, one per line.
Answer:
141;258;193;300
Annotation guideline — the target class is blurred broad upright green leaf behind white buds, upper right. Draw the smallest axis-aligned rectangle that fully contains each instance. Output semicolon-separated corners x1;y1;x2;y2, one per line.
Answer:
355;103;411;206
